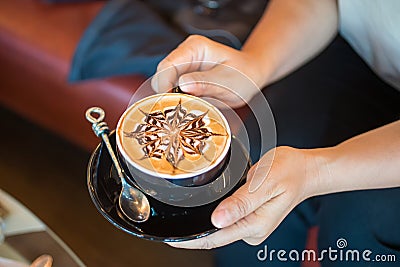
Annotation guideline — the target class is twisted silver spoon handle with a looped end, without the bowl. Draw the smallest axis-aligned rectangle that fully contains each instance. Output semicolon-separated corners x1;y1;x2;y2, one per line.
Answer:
85;107;124;179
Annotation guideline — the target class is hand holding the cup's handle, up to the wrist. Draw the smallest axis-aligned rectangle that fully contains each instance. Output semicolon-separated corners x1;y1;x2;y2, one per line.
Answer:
152;35;262;108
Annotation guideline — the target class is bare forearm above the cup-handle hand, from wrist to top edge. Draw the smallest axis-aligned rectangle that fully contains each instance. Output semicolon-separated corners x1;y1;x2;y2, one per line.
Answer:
242;0;338;87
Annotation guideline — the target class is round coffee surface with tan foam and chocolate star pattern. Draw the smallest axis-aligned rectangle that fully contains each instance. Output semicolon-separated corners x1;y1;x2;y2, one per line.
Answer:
117;93;230;178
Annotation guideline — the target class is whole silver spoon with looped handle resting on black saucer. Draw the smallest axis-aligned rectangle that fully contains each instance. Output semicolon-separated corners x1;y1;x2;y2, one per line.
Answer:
86;107;150;222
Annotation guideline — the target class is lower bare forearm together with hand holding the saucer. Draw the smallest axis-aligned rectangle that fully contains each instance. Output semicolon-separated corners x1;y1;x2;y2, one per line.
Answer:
171;120;400;249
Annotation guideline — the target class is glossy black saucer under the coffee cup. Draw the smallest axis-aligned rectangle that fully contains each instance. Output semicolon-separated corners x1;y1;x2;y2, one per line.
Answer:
87;133;250;242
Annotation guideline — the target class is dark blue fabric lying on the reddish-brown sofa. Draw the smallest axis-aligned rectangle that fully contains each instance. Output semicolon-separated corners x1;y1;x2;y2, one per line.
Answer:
68;0;185;82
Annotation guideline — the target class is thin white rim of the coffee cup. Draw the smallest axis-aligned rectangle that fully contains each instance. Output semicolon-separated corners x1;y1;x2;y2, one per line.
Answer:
116;93;232;180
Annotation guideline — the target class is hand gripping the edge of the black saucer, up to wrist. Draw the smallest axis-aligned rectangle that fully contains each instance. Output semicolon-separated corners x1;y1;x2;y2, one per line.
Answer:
168;147;320;249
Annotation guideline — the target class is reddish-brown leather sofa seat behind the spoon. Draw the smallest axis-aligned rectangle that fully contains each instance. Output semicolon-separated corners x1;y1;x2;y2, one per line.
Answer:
0;0;144;149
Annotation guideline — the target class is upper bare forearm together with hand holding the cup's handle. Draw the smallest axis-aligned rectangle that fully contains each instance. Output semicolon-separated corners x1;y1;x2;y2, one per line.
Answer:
152;0;338;107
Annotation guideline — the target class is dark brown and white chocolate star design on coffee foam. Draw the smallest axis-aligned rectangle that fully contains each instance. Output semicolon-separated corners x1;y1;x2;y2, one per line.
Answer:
125;100;220;169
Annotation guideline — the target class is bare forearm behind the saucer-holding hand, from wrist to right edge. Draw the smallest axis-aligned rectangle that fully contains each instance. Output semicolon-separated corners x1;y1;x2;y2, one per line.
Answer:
310;120;400;195
